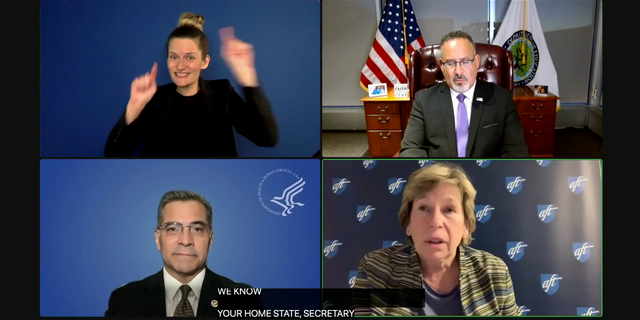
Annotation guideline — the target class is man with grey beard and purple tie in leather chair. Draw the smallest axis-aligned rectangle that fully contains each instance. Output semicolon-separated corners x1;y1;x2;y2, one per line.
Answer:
400;31;529;158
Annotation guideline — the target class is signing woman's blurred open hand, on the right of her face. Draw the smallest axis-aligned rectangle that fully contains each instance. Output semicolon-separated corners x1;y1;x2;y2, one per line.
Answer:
219;27;258;87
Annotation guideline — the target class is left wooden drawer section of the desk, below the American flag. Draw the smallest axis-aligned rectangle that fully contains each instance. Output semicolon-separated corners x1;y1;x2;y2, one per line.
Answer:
360;88;411;158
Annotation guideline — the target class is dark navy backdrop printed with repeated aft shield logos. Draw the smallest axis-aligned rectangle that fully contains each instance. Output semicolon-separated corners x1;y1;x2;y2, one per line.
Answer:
323;160;602;316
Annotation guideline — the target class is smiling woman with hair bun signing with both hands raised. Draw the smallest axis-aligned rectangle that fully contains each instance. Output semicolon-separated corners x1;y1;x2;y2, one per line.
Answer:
105;13;278;158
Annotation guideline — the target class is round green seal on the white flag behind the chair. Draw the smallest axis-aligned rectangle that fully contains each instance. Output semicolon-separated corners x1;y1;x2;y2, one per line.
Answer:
502;30;540;87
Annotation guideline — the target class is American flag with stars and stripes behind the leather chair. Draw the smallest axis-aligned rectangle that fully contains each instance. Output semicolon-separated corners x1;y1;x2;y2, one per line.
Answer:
360;0;425;91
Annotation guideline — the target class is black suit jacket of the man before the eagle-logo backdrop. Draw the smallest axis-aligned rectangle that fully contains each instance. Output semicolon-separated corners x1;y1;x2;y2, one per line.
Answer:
105;269;263;318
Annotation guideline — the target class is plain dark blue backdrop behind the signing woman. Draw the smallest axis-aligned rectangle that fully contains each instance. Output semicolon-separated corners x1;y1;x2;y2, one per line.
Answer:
40;0;321;157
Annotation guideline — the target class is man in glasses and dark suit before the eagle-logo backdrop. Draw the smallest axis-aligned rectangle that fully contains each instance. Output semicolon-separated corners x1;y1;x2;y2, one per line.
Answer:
105;190;263;317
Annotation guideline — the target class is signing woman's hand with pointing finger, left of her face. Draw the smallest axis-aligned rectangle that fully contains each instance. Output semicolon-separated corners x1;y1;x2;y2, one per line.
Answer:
125;63;158;124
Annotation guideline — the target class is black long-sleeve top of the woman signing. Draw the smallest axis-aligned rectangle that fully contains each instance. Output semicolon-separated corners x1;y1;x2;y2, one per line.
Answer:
104;78;278;158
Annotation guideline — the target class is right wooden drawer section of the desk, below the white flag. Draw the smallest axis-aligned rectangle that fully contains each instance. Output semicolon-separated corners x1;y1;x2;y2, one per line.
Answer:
513;86;559;158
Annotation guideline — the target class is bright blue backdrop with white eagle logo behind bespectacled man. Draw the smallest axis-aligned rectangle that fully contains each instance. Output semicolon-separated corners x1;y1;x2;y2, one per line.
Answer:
40;159;321;316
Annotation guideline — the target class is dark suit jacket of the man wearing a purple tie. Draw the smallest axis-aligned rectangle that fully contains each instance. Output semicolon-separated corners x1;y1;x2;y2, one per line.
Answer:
400;80;529;158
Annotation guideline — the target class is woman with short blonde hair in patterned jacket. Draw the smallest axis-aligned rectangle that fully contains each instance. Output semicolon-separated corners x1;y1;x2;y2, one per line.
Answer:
353;163;518;316
